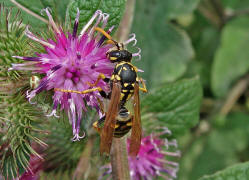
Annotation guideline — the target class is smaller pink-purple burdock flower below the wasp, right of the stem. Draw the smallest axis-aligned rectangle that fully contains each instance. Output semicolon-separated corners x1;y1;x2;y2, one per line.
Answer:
100;129;180;180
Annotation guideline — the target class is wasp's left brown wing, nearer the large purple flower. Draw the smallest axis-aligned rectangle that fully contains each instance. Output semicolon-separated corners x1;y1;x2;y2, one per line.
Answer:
100;82;121;154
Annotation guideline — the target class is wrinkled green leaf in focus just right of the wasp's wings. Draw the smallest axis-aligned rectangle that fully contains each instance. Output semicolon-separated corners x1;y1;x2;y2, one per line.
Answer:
141;78;202;135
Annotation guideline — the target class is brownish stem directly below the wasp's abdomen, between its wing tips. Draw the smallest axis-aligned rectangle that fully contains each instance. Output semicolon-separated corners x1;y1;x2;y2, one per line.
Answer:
111;137;130;180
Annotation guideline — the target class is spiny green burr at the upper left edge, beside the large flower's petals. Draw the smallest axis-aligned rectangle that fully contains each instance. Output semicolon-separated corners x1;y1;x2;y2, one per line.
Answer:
0;4;29;80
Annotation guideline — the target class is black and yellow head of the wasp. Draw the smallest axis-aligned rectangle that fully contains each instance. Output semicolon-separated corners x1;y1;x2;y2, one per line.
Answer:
107;50;132;62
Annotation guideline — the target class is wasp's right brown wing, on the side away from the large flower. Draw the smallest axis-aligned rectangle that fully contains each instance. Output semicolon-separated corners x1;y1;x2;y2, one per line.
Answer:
129;83;142;156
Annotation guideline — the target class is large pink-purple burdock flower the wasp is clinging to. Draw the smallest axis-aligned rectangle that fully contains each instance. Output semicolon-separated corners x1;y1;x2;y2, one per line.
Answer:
10;8;140;141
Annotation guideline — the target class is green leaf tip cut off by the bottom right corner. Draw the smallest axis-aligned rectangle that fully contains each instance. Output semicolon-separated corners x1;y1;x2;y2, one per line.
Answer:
199;162;249;180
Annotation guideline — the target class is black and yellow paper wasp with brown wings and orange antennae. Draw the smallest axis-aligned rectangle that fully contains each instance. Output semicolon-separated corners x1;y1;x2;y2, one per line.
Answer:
55;27;147;156
